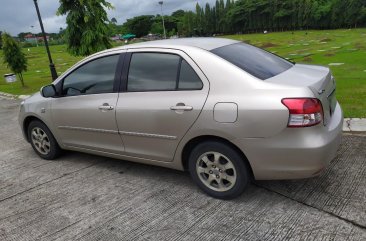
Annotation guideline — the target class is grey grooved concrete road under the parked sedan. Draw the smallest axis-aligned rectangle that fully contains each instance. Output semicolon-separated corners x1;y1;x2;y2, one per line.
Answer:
0;97;366;241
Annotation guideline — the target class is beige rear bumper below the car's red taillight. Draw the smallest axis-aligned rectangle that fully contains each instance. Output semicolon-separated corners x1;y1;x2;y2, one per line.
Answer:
234;104;343;180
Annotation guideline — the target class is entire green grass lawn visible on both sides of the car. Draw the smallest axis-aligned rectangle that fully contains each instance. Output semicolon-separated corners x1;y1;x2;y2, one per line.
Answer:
0;29;366;117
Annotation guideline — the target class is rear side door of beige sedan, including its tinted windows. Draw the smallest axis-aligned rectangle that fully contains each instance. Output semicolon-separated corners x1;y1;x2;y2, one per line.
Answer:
116;49;209;162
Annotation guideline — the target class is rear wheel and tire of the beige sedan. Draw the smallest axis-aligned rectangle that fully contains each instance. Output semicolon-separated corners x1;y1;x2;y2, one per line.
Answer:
188;141;250;200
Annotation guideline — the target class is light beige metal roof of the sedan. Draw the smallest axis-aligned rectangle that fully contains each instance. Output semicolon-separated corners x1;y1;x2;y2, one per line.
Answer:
114;37;239;51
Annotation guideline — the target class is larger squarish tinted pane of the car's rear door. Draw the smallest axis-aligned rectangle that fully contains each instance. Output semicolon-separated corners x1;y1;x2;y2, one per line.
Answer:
127;53;180;91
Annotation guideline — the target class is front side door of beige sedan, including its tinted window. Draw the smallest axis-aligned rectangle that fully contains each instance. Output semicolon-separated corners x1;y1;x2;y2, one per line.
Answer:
52;54;124;153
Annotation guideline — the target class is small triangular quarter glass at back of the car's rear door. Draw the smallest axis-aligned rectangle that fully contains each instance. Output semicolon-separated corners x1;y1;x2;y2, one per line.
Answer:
178;60;202;90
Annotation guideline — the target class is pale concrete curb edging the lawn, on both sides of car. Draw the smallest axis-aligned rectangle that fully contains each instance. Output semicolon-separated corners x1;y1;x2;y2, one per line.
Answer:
0;92;366;132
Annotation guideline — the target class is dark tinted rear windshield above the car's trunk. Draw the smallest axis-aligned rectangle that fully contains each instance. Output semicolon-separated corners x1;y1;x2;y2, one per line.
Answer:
211;43;293;80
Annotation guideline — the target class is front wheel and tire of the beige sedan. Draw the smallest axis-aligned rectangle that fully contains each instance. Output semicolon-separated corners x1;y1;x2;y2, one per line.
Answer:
27;120;61;160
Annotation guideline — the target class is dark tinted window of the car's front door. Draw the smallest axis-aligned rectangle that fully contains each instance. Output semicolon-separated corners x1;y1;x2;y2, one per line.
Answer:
63;55;119;96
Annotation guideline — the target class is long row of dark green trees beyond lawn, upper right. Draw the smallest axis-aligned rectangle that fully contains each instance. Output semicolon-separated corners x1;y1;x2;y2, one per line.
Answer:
124;0;366;36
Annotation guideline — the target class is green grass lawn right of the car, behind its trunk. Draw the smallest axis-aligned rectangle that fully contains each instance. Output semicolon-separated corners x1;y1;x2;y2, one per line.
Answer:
225;29;366;117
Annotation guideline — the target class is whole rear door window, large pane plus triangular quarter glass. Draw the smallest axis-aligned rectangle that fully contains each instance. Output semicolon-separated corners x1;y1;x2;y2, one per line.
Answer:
127;53;203;92
